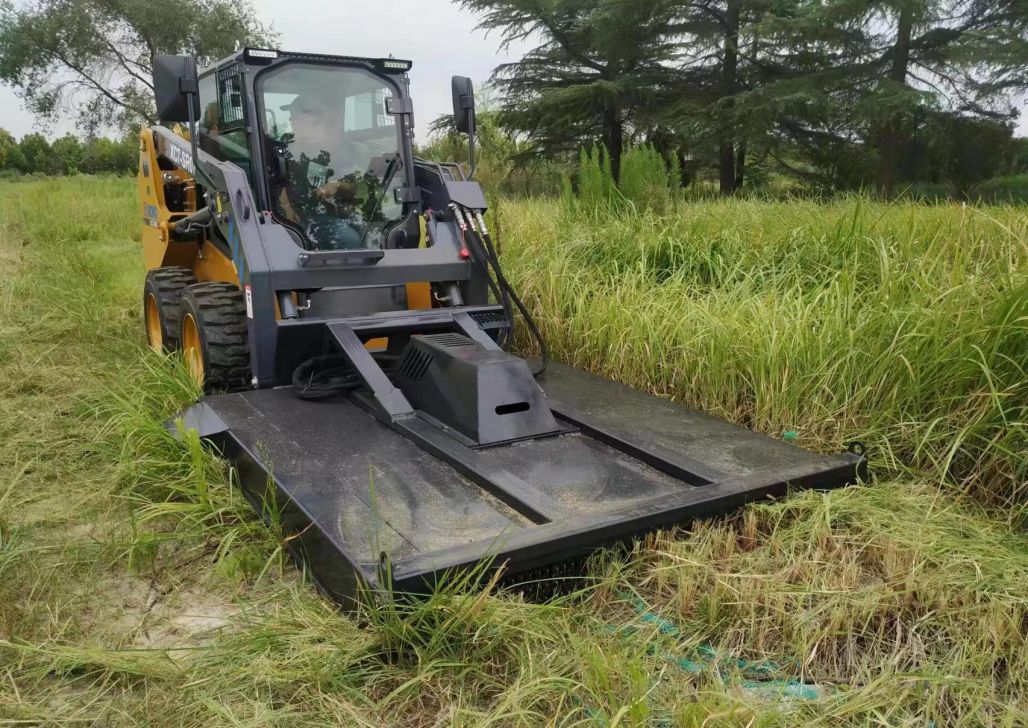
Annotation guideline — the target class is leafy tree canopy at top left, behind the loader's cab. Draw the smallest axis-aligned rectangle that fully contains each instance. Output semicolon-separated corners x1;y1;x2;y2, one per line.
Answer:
0;0;270;134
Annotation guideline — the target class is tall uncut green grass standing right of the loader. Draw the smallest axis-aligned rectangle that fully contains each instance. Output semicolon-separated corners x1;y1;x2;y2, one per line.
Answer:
499;197;1028;506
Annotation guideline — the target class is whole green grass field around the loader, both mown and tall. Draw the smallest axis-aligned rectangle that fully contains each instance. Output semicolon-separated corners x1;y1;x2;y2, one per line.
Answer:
0;178;1028;728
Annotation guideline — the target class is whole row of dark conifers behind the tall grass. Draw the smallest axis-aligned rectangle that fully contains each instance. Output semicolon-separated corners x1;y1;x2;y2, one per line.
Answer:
461;0;1028;192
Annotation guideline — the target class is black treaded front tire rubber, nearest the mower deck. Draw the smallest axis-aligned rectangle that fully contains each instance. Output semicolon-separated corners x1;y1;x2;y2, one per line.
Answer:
179;282;250;394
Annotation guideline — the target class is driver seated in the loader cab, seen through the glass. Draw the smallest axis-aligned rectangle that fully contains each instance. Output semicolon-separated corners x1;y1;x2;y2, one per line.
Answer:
280;90;374;250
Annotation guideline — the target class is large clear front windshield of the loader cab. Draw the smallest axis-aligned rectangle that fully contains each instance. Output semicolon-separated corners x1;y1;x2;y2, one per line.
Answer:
257;64;403;250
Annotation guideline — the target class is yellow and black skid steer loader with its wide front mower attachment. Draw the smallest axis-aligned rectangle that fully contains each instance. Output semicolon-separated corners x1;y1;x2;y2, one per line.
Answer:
139;48;866;605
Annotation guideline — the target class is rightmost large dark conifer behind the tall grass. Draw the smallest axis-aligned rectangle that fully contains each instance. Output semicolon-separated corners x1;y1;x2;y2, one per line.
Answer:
781;0;1028;193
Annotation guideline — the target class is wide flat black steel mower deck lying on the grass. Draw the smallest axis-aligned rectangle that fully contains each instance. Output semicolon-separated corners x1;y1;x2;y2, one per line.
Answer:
183;364;866;603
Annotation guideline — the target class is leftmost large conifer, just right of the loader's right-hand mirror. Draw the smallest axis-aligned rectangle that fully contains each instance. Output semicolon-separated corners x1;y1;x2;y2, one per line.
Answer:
461;0;676;179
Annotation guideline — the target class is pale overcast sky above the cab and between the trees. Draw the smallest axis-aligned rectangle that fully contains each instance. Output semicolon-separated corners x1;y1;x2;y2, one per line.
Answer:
0;0;1028;138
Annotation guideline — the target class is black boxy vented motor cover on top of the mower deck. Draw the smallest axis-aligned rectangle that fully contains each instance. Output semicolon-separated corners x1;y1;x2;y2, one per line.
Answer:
397;333;561;445
